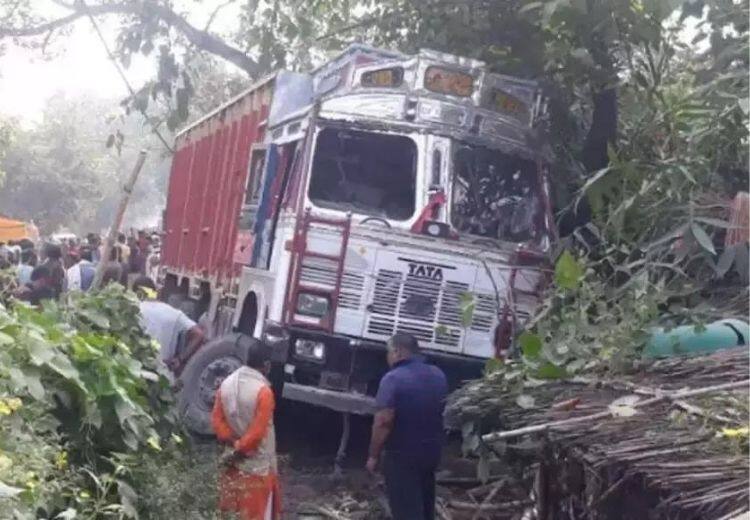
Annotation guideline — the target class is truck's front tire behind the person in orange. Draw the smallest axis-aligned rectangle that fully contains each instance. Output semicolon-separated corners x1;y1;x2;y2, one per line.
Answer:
178;333;258;435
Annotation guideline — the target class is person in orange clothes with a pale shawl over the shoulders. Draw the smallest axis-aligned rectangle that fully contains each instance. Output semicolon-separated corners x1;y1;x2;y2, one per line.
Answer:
211;342;281;520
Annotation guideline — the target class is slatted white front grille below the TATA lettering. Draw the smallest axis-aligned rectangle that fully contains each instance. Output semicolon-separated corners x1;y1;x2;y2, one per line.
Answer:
367;269;496;347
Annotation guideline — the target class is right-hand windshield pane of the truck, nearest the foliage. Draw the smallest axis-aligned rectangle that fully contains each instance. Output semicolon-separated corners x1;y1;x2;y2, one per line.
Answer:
451;143;541;242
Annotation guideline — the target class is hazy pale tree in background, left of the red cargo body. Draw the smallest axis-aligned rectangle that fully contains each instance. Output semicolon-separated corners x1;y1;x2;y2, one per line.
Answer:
0;95;168;233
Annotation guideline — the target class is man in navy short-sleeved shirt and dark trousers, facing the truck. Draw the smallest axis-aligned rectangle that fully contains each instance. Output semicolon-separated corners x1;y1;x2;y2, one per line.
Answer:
367;333;448;520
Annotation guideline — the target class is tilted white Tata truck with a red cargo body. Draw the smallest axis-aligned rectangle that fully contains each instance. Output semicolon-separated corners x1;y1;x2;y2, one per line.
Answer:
159;45;555;442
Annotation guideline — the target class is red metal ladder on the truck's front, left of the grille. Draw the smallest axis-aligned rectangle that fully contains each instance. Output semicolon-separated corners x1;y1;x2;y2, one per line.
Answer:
284;208;352;333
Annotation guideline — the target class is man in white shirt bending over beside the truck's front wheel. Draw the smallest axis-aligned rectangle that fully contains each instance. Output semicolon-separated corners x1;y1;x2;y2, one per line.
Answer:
133;276;205;377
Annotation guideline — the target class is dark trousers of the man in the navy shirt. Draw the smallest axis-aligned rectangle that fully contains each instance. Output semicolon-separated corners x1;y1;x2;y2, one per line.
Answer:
383;451;438;520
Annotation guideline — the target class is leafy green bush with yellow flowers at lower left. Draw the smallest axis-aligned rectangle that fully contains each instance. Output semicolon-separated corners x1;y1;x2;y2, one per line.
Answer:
0;285;174;519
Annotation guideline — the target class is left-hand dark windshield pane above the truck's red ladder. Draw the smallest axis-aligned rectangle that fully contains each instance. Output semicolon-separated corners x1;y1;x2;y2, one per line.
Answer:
309;128;417;220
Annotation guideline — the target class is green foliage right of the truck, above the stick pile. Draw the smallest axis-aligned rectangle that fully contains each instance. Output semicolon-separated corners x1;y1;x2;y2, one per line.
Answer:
450;10;750;486
